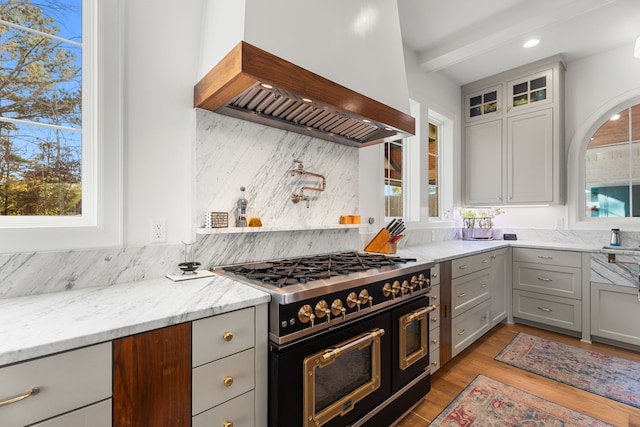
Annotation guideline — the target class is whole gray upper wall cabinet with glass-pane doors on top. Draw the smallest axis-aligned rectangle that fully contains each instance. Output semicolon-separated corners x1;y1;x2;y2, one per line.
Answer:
462;57;564;205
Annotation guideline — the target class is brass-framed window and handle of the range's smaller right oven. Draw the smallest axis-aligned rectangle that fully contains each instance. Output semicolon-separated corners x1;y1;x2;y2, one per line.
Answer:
399;306;435;370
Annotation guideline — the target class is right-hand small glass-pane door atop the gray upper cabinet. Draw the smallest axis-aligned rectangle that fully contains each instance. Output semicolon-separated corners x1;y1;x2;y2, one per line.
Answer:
507;70;553;112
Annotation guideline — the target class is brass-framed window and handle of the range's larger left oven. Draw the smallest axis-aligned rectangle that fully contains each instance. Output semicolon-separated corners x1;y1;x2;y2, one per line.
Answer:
303;329;384;427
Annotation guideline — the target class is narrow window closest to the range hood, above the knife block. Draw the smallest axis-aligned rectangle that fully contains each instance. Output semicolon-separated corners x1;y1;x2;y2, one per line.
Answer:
384;139;405;218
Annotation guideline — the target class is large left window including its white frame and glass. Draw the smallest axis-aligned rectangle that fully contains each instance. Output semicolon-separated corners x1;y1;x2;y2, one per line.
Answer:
0;0;122;252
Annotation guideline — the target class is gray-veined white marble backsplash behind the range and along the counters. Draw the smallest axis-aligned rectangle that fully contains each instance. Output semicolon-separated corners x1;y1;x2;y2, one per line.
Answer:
5;111;640;298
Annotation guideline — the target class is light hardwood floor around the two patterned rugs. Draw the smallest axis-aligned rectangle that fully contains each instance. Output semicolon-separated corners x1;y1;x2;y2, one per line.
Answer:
395;324;640;427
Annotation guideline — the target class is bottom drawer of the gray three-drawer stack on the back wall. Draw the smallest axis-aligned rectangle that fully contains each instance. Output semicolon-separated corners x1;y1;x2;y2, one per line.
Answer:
513;289;582;332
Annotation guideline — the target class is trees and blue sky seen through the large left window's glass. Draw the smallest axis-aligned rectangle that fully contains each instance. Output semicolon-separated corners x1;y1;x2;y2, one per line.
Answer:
0;0;82;216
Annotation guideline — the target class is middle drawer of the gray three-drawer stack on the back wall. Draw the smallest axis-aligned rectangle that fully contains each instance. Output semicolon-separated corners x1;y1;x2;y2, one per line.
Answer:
513;262;582;299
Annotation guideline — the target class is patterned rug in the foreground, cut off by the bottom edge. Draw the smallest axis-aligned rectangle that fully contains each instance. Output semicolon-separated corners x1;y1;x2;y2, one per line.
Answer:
429;375;611;427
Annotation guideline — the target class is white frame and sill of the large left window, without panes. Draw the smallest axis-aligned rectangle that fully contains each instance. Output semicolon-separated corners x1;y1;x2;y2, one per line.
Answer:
0;0;123;253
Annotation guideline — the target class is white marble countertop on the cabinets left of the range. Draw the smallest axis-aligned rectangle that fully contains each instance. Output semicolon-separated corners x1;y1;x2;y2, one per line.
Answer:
0;276;270;366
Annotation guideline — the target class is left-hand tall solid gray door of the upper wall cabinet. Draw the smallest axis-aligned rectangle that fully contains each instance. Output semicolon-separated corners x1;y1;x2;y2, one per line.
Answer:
464;120;502;204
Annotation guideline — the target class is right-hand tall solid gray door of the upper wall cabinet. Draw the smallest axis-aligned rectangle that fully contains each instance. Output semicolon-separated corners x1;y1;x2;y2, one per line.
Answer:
507;108;558;203
